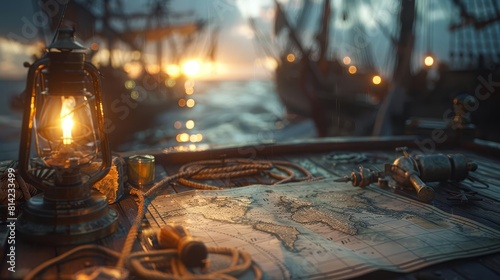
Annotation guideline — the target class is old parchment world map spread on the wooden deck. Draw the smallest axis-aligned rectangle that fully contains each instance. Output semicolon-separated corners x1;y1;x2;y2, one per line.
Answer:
149;180;500;279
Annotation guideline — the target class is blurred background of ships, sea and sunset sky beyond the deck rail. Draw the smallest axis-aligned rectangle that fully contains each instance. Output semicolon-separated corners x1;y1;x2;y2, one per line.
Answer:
0;0;500;160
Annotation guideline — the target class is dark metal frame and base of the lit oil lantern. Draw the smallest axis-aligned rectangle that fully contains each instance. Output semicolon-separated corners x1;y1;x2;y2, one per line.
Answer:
16;29;118;245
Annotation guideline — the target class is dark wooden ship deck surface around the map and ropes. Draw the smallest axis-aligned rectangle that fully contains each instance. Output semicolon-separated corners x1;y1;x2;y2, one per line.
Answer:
0;137;500;279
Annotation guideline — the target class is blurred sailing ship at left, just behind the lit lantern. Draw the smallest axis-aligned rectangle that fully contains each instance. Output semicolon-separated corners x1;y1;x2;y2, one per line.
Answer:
11;0;216;148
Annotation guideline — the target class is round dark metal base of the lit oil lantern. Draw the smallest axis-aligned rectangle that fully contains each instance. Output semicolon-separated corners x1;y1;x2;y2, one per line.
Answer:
16;191;118;245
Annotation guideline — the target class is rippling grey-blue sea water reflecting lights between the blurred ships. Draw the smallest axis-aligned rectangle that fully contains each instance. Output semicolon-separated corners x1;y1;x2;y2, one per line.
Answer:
0;80;316;160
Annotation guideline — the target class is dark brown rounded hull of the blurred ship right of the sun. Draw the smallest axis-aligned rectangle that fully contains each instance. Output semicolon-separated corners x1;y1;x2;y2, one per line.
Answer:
275;60;387;136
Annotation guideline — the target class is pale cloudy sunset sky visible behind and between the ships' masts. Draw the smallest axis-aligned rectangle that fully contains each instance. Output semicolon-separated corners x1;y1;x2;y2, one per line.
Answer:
0;0;454;79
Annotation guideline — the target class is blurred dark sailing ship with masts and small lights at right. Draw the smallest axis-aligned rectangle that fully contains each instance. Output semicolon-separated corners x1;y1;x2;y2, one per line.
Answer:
251;0;500;140
